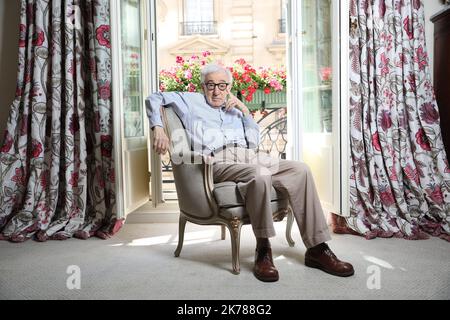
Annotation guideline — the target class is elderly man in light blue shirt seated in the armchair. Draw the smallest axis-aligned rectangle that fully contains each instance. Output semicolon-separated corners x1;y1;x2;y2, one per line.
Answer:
147;64;354;282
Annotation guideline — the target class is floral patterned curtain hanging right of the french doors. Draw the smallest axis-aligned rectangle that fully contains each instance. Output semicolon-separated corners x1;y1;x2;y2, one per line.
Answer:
346;0;450;241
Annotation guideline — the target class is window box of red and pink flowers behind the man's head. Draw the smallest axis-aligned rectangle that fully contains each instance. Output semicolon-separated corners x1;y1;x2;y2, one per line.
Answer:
159;51;286;113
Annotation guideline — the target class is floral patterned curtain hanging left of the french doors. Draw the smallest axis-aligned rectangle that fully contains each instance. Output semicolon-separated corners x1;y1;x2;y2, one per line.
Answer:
0;0;122;242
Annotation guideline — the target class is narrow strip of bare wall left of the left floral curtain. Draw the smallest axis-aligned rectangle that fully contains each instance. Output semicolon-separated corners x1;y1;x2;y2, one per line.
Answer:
0;0;20;135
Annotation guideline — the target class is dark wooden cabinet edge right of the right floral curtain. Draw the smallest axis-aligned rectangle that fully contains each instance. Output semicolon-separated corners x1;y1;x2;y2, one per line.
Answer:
431;6;450;157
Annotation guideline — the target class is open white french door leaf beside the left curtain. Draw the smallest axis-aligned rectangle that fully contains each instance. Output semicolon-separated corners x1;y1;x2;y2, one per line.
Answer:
110;0;151;217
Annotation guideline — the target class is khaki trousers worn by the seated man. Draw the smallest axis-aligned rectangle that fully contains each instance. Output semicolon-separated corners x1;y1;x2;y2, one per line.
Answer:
213;147;331;248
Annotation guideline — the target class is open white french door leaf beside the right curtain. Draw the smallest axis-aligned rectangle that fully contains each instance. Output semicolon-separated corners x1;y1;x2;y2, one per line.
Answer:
287;0;348;214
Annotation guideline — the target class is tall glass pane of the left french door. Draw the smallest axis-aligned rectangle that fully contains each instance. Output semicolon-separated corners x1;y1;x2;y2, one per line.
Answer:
121;0;144;138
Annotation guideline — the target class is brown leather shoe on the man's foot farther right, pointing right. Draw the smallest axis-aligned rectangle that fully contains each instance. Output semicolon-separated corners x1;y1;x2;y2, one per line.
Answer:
305;243;355;277
